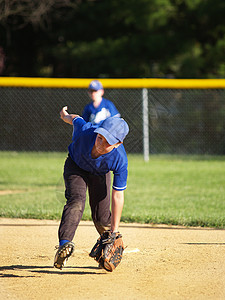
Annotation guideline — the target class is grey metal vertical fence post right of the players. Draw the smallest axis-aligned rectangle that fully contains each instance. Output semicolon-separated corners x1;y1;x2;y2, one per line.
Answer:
142;88;149;161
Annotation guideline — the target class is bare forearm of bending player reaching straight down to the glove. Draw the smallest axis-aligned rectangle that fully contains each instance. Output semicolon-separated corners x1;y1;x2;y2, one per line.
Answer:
111;189;124;232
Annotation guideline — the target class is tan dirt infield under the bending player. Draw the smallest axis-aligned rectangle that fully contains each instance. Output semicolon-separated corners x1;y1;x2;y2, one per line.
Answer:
0;218;225;300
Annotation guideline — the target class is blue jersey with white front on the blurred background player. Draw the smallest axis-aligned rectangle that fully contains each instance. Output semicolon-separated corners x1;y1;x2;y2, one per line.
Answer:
82;98;120;124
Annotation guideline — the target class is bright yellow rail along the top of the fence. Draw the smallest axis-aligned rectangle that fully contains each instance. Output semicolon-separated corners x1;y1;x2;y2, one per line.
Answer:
0;77;225;89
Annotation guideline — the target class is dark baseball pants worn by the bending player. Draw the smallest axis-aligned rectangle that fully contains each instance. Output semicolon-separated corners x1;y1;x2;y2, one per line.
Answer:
58;155;111;241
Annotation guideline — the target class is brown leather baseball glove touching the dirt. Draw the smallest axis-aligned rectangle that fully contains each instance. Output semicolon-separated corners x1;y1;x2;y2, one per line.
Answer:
89;230;124;272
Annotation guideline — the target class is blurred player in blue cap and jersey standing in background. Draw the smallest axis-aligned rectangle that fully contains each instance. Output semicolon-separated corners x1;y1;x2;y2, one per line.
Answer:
82;80;120;124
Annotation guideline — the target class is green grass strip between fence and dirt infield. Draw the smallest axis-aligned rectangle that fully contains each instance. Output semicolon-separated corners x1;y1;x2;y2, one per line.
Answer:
0;152;225;228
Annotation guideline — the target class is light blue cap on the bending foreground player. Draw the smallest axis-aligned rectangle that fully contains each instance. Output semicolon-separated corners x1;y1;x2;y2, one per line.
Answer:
94;117;129;145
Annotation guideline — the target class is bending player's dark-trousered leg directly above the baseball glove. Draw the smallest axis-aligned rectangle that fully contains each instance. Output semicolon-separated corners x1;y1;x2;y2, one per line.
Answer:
88;172;111;234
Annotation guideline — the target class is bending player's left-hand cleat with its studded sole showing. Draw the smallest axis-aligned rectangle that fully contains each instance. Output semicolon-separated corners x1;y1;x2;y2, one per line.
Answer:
54;242;75;270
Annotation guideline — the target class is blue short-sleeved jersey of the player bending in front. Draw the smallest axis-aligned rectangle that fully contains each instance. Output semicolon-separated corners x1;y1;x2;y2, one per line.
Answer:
68;117;128;191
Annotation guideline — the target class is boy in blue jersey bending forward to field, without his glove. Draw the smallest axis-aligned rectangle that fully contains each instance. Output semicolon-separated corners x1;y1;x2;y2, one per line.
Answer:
54;106;129;269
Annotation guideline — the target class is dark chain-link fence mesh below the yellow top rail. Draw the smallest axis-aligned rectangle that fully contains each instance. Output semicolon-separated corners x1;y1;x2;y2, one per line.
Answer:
0;87;225;155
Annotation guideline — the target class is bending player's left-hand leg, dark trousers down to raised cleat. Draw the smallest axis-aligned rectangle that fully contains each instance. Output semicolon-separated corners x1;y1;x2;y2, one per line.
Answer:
54;157;87;269
